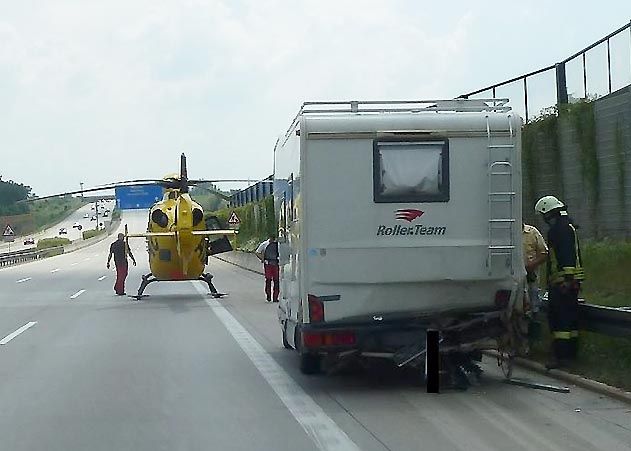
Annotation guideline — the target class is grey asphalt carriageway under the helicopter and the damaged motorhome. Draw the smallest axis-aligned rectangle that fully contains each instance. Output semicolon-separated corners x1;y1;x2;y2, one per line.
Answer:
0;212;631;451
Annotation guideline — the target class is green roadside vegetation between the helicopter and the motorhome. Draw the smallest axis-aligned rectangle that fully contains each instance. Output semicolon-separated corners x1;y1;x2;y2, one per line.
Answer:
212;196;277;252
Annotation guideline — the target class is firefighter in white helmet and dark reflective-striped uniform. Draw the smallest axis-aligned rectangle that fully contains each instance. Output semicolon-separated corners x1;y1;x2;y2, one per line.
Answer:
535;196;585;369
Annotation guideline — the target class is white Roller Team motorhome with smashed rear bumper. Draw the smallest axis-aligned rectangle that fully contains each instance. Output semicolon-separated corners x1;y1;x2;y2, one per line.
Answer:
274;99;525;373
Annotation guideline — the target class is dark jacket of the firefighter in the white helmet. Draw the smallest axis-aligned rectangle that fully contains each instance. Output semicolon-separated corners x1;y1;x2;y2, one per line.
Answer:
548;215;585;285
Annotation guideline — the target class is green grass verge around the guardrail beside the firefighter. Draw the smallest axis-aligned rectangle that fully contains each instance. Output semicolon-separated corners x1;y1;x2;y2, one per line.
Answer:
530;241;631;390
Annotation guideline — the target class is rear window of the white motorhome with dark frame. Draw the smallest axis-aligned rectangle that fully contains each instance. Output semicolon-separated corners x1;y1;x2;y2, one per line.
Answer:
373;141;449;203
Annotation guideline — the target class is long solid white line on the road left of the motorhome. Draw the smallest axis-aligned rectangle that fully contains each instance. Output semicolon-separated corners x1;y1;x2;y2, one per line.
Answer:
193;283;359;451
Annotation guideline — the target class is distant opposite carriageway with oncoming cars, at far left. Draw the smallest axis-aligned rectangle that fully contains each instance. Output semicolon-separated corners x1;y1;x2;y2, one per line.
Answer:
0;200;115;253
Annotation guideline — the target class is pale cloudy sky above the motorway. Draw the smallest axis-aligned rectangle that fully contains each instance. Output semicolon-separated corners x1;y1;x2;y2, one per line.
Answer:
0;0;631;195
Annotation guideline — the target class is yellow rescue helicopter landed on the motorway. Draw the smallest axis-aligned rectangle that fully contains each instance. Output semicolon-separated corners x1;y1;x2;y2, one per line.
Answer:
29;153;249;299
